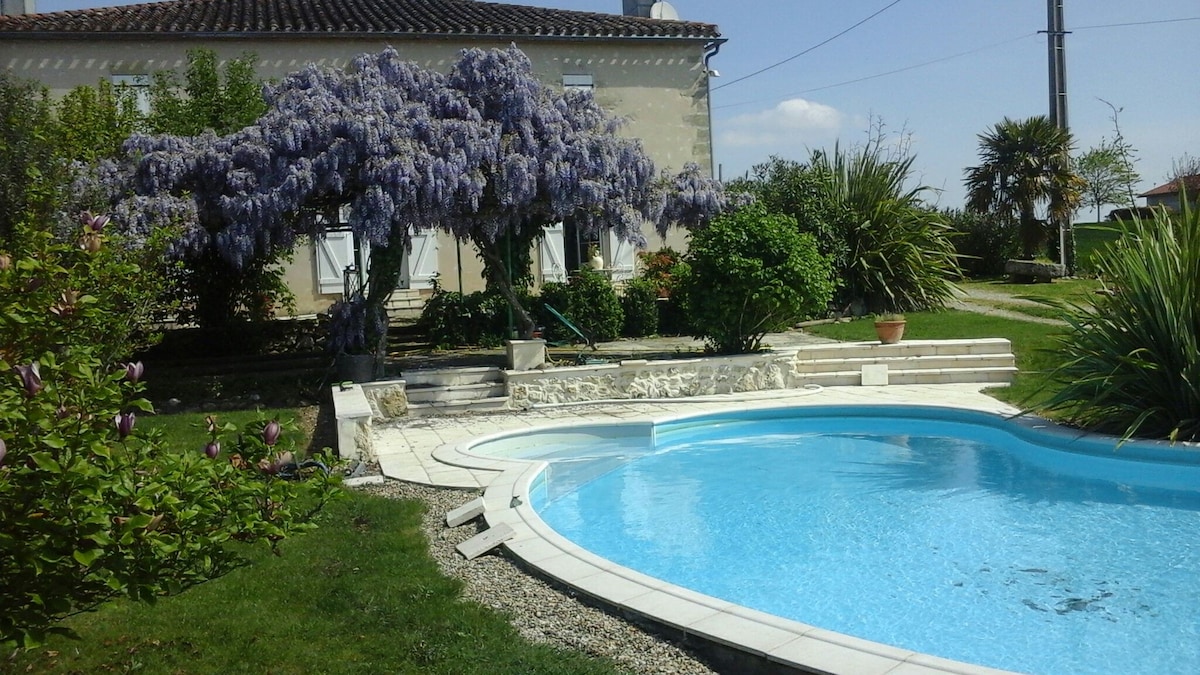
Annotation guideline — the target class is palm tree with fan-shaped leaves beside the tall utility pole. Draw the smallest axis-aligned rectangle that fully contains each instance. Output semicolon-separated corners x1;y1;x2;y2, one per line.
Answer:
965;115;1084;258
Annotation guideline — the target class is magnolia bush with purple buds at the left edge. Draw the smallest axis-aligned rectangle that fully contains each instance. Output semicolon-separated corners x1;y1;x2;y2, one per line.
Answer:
0;219;337;647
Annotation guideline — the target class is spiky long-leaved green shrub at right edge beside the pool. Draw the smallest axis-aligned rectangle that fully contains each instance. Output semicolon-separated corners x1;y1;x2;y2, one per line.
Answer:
1044;199;1200;441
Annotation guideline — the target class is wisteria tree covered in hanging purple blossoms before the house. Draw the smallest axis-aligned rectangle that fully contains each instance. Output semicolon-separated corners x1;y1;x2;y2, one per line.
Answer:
124;47;724;353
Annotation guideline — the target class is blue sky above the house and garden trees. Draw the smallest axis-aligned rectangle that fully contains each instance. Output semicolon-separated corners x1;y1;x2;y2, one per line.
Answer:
37;0;1200;211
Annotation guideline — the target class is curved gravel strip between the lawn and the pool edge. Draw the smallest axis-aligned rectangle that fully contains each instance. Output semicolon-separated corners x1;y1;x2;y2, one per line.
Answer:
356;479;716;675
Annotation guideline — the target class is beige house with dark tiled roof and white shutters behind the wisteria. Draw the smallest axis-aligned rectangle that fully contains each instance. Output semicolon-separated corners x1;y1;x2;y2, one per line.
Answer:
0;0;722;313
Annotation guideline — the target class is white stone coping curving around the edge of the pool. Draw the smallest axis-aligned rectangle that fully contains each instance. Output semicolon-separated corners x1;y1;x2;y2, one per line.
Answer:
433;388;1020;675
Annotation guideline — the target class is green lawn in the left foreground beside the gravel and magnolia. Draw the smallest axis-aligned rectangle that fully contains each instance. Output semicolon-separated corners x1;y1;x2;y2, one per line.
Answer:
9;411;617;675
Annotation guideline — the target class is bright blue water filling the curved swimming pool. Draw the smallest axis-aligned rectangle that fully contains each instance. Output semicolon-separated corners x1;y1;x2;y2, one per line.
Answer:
529;407;1200;674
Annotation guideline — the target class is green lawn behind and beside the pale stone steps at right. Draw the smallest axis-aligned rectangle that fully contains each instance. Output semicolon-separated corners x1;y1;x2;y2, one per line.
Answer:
806;309;1063;406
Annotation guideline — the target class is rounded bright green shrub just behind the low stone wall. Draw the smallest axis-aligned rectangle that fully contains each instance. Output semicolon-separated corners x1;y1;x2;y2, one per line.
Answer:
679;204;833;353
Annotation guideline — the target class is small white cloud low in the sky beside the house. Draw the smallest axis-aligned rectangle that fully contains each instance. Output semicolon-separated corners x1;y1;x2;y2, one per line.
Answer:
718;98;845;148
